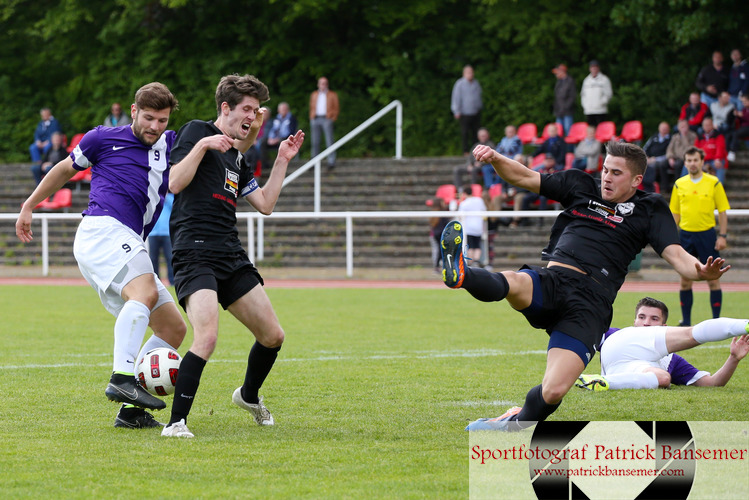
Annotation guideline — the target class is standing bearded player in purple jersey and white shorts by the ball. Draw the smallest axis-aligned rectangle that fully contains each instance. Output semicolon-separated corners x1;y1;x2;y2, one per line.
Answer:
16;82;187;428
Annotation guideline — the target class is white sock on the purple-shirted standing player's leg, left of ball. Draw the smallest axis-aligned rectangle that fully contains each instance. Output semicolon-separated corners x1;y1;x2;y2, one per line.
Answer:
112;300;151;373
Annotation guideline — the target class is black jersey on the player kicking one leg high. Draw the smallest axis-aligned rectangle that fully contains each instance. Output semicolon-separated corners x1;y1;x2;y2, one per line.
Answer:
540;169;679;300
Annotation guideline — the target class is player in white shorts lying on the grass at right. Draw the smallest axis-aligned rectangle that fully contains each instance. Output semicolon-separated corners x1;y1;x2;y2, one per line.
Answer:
576;297;749;391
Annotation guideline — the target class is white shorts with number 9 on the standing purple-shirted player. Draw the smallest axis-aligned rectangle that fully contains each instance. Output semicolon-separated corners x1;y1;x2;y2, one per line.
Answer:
73;216;174;317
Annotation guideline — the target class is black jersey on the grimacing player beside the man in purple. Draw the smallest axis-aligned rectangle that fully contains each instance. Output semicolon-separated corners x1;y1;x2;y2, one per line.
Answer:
169;120;257;252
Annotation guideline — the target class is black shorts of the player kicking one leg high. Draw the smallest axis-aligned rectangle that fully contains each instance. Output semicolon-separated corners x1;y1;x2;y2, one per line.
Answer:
519;266;614;364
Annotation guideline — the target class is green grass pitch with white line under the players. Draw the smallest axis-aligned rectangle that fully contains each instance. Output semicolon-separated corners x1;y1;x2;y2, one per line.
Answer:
0;286;749;499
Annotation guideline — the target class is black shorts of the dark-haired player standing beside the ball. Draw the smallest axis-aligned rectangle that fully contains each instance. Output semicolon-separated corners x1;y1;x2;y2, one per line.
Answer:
172;249;264;310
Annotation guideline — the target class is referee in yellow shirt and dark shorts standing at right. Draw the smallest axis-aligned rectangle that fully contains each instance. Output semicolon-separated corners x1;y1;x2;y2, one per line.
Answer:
671;146;731;326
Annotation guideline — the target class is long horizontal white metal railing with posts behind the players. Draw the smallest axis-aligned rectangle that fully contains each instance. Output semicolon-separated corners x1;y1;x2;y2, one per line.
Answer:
5;209;749;278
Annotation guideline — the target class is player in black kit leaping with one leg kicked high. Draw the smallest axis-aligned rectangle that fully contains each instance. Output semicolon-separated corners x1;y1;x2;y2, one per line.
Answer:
441;142;728;431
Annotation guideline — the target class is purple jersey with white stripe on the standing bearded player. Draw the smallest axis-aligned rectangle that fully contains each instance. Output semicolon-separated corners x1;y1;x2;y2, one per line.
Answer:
70;125;176;239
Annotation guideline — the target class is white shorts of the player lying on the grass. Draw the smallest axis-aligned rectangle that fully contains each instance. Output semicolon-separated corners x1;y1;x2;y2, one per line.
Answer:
601;326;671;376
